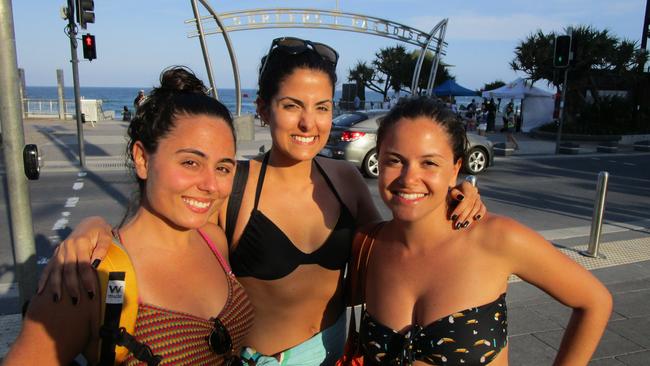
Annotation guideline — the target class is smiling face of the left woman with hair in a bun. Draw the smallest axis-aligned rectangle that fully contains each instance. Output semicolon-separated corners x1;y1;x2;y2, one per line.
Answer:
133;115;235;229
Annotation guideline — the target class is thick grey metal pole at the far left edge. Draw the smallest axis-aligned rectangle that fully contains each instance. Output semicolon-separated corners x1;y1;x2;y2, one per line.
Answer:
0;0;37;305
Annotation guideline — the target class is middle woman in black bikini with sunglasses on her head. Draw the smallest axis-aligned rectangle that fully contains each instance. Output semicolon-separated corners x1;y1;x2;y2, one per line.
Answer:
34;37;485;365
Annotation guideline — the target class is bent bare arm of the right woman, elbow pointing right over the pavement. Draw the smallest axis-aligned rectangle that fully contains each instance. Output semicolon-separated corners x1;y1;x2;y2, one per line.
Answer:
498;219;612;365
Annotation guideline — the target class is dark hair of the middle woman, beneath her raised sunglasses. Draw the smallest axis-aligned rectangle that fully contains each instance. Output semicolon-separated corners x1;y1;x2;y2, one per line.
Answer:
257;39;337;105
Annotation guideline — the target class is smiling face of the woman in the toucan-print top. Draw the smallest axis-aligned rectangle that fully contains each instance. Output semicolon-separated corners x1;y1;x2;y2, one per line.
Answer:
378;117;461;222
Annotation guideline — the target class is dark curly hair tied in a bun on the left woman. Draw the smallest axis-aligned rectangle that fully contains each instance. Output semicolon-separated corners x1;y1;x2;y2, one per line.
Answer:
122;66;236;222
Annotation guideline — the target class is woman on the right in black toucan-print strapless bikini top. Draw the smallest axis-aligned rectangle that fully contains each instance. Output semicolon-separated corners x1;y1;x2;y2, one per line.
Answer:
355;97;612;366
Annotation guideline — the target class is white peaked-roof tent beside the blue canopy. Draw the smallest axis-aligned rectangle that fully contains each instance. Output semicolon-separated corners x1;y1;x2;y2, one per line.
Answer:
482;78;555;132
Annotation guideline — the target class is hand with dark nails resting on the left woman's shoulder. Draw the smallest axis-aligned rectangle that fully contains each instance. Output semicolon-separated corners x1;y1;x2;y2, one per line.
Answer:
38;216;113;302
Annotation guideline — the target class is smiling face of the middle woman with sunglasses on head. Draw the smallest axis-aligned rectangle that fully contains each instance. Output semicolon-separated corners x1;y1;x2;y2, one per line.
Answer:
258;68;334;161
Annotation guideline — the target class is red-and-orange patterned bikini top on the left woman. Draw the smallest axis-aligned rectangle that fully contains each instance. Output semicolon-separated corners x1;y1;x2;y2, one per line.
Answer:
124;231;253;365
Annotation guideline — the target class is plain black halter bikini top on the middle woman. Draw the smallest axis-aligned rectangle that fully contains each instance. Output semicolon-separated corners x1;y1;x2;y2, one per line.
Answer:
226;153;356;280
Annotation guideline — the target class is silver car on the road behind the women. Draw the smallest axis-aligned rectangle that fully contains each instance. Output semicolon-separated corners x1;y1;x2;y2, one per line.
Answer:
319;110;494;178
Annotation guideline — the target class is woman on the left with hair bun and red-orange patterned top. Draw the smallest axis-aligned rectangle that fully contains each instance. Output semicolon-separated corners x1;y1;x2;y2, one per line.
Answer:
4;67;253;366
